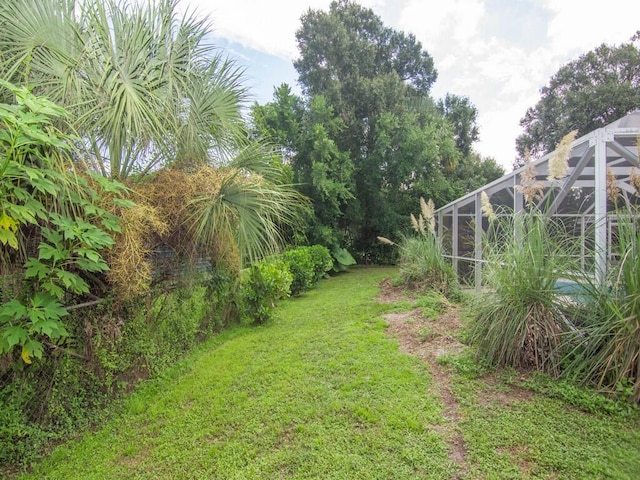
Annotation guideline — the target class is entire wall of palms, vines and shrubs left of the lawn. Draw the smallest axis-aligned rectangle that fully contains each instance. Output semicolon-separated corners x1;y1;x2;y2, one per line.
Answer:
0;0;316;471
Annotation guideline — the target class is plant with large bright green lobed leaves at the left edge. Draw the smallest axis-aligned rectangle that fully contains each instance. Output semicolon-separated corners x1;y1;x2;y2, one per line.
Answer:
0;81;130;363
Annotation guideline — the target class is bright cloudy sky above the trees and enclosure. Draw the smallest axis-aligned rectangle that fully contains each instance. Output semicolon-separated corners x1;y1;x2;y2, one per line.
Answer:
181;0;640;171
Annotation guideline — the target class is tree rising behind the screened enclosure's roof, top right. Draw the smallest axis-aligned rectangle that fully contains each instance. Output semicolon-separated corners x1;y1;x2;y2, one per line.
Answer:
516;35;640;158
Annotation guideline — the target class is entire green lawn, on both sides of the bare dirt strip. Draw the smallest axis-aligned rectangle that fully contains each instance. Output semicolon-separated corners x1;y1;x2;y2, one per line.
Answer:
15;268;640;479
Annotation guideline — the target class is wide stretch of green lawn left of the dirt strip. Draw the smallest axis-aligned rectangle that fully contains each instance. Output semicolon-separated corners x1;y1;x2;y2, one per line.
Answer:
18;269;455;479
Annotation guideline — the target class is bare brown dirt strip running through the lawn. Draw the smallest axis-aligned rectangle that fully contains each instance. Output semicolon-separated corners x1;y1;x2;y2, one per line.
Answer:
378;280;467;478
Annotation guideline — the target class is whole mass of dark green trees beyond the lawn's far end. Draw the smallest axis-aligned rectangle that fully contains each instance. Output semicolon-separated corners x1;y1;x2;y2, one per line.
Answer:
253;0;502;262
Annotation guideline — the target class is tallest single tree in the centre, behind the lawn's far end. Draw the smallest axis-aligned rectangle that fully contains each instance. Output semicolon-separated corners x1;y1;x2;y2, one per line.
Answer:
294;0;459;256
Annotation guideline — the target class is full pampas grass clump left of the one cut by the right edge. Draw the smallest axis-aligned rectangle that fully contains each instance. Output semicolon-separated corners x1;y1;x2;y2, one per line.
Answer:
471;211;573;375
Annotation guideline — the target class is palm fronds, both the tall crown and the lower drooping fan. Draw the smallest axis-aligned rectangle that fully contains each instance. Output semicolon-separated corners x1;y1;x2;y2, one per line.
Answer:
0;0;300;282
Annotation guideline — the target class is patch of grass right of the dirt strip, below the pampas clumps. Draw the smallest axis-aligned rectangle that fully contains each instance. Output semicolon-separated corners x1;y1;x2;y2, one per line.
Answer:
454;379;640;479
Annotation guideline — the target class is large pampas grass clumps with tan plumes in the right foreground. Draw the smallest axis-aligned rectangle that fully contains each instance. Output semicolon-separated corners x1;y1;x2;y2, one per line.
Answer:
471;131;640;403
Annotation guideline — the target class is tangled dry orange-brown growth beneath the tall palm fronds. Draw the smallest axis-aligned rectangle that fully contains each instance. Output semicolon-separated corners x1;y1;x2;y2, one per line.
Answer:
105;167;242;299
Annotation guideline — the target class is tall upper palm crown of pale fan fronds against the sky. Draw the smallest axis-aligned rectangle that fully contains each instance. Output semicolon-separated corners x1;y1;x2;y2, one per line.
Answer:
0;0;246;179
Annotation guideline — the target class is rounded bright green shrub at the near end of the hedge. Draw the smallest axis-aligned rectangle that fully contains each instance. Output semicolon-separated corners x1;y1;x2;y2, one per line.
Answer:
241;258;293;323
